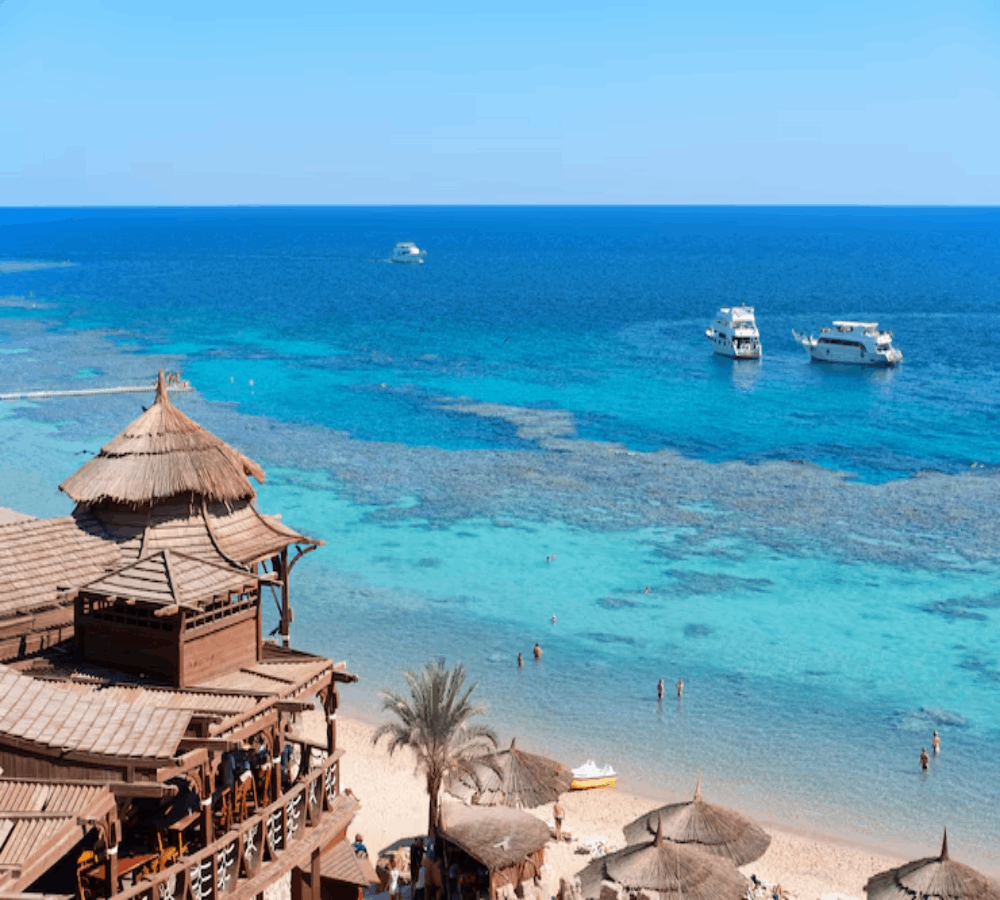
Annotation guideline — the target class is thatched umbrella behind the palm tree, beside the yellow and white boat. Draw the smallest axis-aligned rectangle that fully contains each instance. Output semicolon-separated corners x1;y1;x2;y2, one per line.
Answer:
448;737;573;809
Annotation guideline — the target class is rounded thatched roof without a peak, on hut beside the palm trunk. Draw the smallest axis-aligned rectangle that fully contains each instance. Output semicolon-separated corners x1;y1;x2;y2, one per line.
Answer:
441;803;550;871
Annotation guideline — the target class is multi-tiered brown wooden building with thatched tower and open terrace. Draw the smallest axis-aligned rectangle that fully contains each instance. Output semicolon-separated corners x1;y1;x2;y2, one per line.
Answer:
0;373;362;900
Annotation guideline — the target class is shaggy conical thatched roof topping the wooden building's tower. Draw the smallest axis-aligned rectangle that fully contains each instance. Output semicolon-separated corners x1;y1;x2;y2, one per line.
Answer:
59;369;264;506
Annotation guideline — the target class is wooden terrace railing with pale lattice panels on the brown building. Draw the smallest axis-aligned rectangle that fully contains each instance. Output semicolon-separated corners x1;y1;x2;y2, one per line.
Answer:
110;754;340;900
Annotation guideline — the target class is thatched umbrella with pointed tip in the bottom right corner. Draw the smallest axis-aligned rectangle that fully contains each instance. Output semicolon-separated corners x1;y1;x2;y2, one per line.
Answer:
865;829;1000;900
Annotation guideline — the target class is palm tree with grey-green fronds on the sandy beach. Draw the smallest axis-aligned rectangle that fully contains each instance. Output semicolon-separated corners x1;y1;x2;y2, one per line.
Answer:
372;660;497;835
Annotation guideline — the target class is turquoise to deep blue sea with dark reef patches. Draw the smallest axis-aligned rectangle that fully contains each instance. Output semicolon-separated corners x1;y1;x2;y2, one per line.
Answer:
0;207;1000;874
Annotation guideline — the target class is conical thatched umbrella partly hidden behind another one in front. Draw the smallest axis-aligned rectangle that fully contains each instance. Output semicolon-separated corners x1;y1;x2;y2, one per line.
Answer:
625;778;771;866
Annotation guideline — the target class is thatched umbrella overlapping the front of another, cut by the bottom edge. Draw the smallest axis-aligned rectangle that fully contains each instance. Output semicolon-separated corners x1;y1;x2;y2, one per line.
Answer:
580;827;748;900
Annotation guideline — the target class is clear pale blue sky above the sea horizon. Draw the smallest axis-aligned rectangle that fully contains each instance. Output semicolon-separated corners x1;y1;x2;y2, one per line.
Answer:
0;0;1000;206
